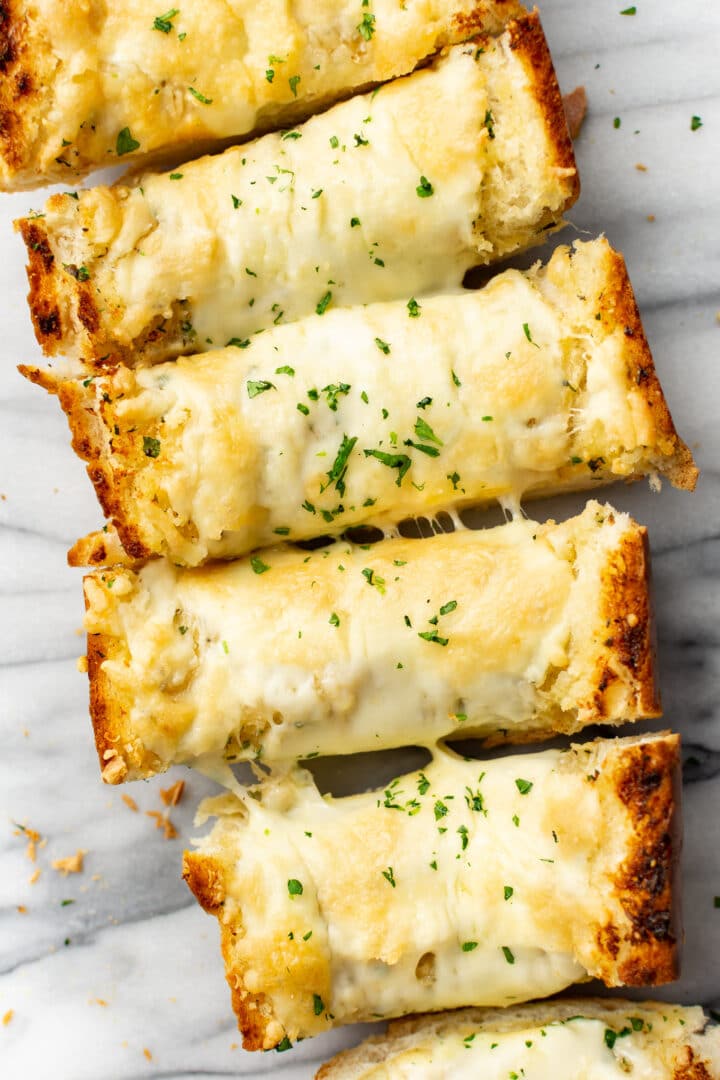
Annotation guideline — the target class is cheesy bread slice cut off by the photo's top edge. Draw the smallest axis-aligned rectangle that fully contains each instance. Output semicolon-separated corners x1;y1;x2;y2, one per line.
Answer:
0;0;525;191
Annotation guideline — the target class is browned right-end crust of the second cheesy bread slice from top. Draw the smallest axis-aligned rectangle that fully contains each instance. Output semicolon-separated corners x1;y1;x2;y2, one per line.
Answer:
507;11;580;210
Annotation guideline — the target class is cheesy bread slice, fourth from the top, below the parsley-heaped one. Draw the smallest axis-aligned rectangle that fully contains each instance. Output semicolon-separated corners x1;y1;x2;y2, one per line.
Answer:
85;502;658;783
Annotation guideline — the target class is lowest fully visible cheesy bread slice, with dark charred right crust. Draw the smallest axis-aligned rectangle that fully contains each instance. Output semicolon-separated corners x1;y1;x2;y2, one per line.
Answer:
185;733;679;1049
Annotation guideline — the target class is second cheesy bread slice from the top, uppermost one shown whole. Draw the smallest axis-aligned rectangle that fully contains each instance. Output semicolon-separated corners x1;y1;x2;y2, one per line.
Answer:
18;15;579;366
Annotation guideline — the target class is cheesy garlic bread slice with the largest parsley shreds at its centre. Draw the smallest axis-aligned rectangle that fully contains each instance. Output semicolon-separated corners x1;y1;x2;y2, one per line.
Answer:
23;240;696;566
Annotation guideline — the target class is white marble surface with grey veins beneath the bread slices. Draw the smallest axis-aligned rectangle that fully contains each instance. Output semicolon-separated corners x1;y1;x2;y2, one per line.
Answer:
0;0;720;1080
